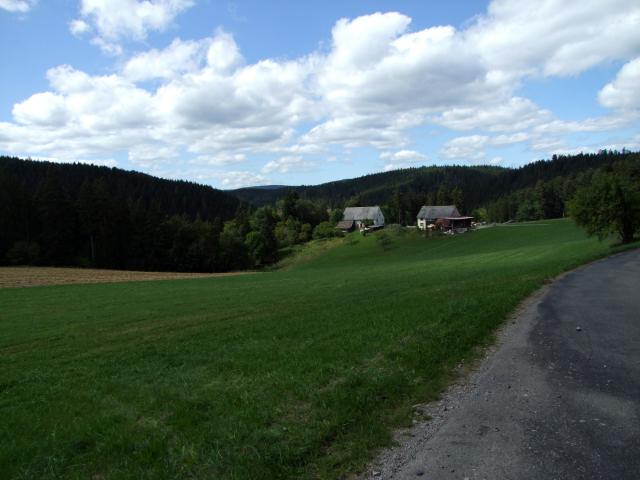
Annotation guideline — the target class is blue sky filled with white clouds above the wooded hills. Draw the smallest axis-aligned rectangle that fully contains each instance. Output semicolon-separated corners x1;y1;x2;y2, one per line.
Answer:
0;0;640;189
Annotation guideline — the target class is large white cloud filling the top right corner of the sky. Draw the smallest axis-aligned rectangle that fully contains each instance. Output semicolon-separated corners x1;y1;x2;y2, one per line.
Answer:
465;0;640;76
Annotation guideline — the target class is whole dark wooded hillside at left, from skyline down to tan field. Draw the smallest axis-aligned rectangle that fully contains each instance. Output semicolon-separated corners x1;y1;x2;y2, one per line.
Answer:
0;157;240;271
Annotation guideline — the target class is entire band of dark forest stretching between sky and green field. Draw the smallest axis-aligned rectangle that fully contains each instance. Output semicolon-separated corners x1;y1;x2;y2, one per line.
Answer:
0;150;640;272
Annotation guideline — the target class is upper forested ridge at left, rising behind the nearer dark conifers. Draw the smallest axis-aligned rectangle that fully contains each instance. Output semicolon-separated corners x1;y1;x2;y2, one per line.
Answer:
0;157;240;221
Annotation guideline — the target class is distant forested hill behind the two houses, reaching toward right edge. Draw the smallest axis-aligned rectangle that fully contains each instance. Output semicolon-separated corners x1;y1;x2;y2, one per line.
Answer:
230;150;634;211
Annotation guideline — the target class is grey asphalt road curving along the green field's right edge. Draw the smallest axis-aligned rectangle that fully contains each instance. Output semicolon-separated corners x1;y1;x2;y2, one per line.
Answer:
388;251;640;480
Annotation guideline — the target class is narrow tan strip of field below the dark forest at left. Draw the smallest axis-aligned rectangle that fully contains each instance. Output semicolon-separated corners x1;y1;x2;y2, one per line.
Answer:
0;267;255;288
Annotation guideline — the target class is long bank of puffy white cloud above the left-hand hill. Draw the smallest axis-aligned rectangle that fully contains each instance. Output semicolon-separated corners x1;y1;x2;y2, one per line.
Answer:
0;31;314;166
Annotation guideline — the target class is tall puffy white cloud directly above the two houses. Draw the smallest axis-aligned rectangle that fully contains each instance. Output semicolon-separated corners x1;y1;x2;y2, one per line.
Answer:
312;12;496;148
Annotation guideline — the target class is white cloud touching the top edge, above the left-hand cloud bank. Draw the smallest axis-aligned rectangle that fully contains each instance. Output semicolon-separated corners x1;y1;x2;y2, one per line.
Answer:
69;0;194;53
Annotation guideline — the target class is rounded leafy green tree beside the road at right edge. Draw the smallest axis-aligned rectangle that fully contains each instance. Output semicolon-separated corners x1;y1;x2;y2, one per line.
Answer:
569;164;640;243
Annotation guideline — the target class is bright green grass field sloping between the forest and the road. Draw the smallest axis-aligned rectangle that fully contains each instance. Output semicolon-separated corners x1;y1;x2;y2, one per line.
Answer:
0;220;624;480
